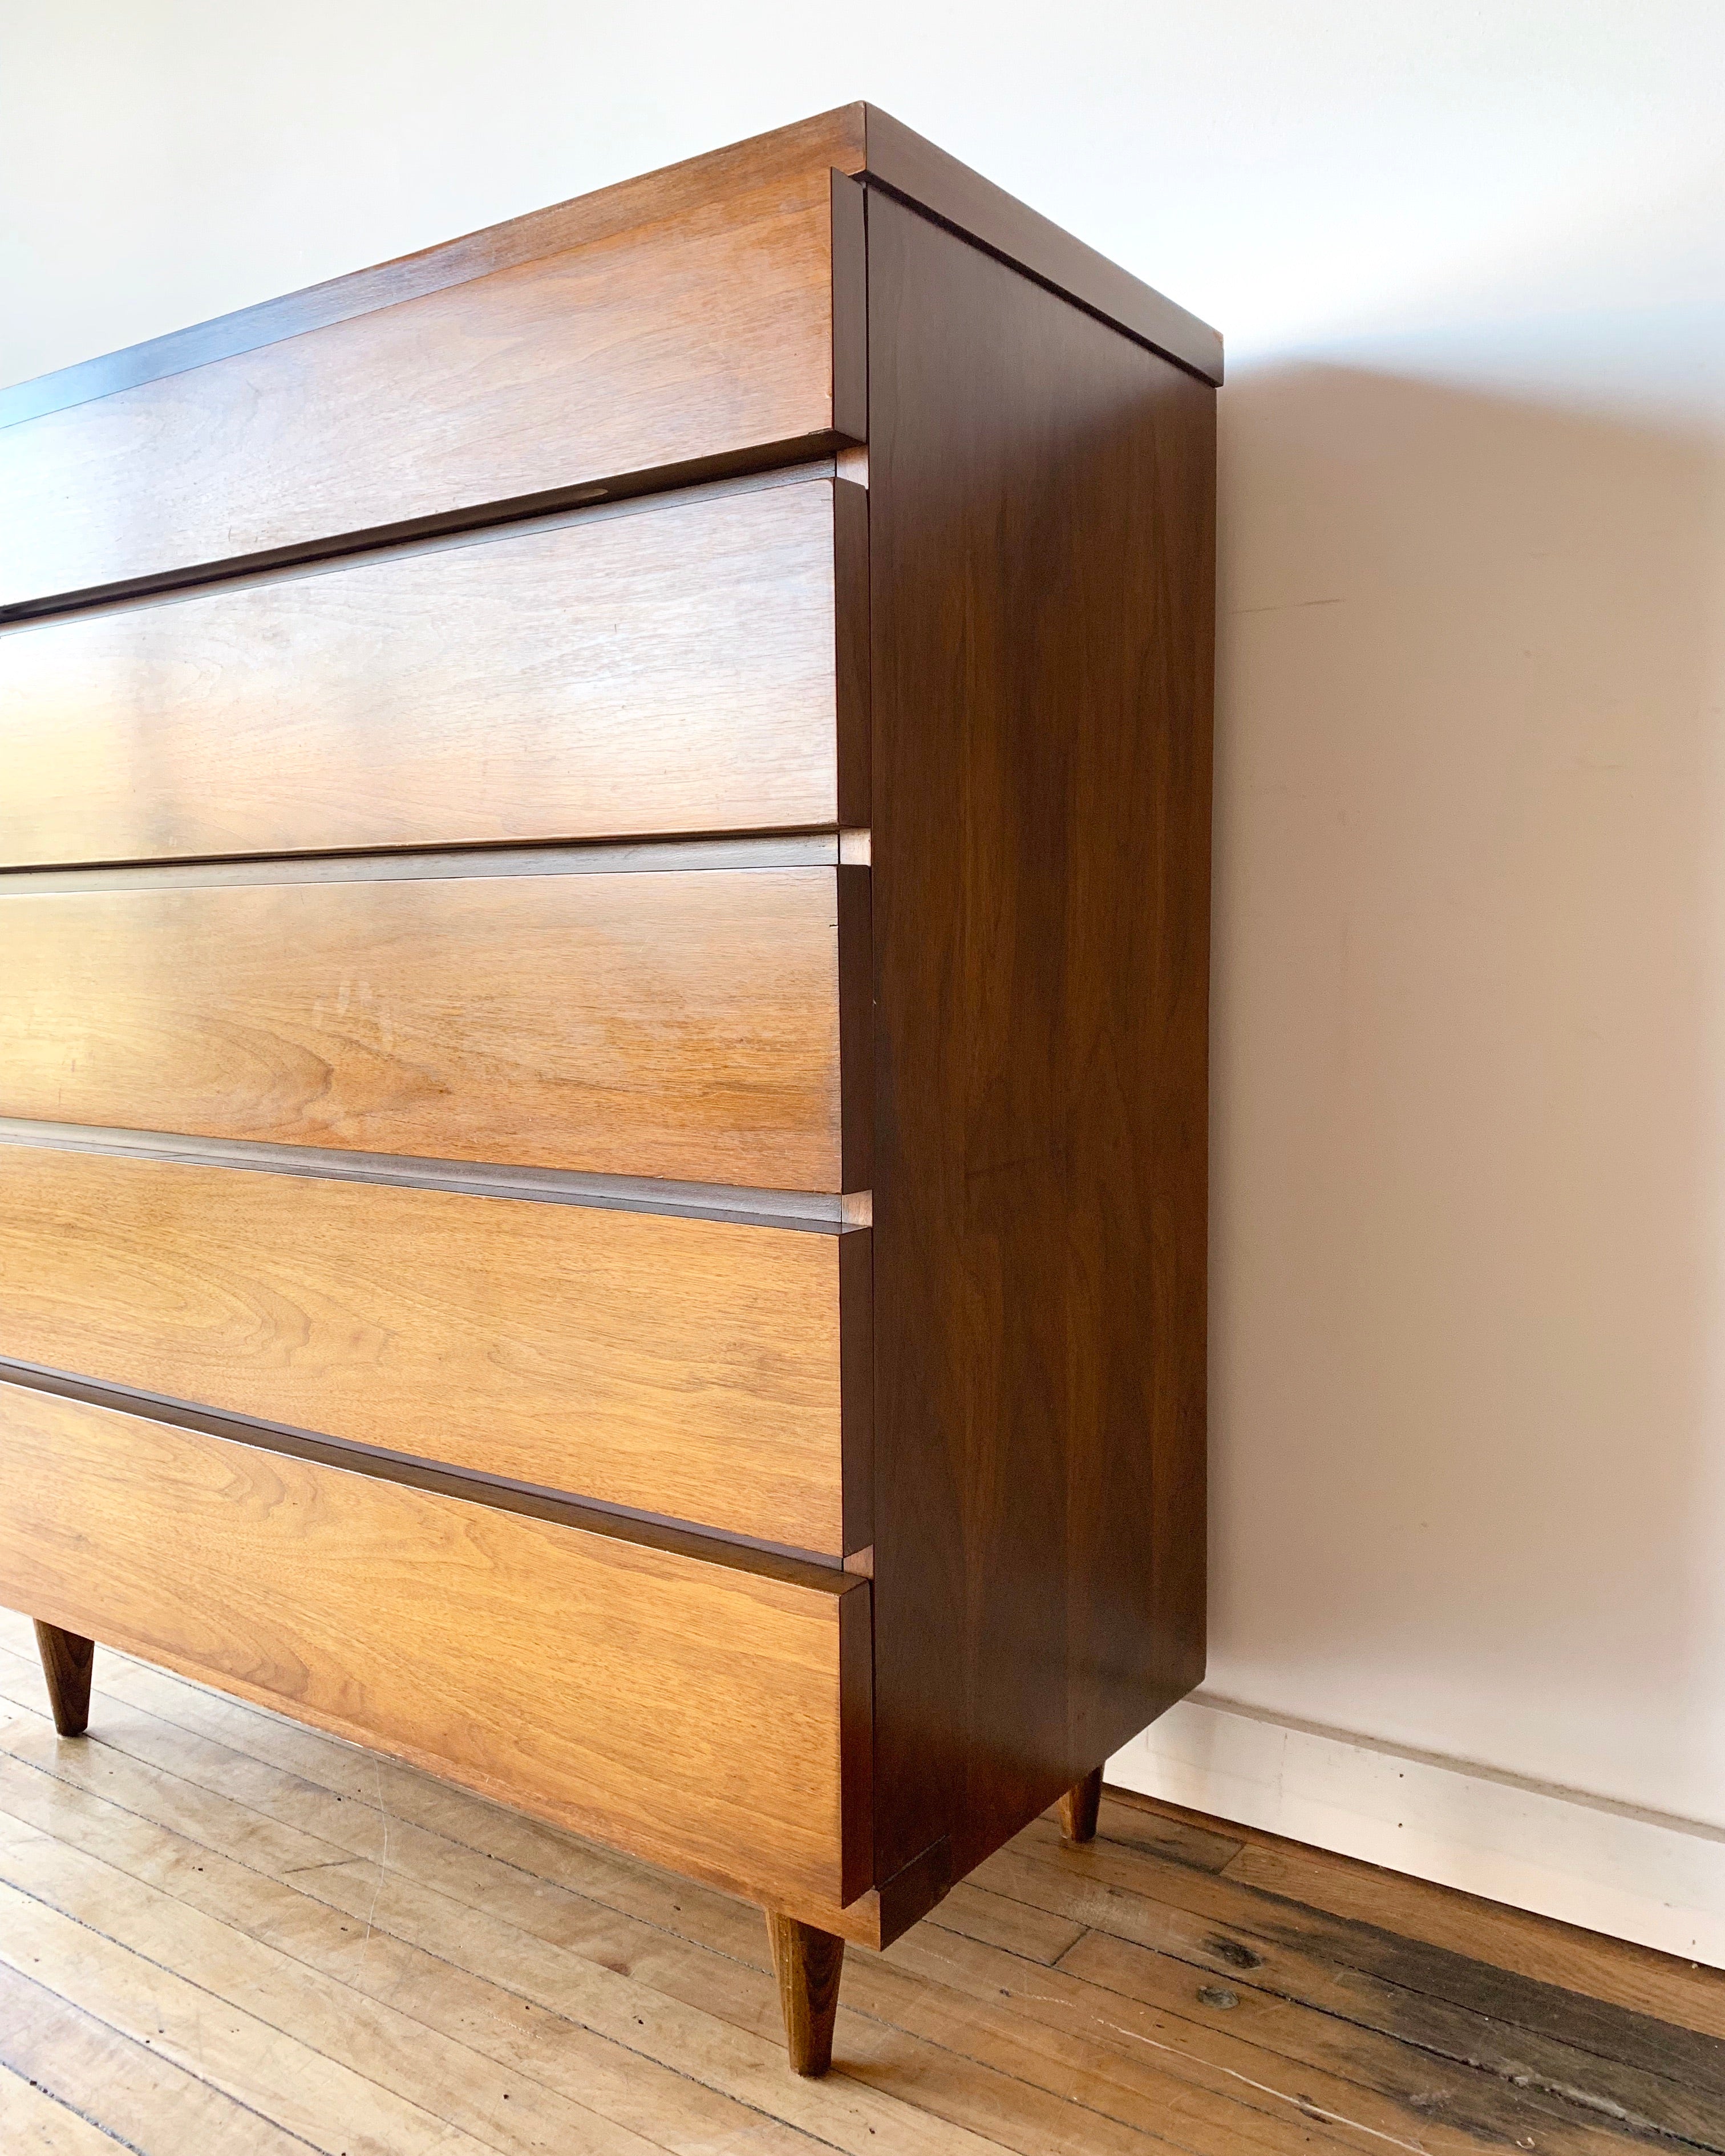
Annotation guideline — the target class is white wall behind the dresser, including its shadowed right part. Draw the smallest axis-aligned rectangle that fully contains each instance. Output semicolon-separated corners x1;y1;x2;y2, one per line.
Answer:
0;0;1725;1940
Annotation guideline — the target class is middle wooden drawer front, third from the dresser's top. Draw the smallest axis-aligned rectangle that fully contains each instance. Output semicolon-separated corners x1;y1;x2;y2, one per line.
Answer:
0;869;867;1190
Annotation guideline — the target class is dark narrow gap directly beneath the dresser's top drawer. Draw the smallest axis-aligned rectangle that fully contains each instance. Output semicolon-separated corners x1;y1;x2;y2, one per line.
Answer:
0;431;845;627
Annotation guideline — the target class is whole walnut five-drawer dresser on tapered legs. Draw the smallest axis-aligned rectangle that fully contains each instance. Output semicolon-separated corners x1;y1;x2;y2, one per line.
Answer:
0;106;1220;2072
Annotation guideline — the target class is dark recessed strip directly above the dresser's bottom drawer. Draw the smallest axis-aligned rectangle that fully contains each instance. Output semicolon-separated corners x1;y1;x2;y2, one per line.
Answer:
0;1356;869;1595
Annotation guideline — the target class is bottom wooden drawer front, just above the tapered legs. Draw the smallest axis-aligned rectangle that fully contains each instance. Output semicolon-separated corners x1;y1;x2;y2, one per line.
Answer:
0;1384;869;1902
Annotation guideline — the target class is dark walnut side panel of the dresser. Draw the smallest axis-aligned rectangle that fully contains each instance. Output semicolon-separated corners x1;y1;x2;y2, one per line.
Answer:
869;194;1214;1876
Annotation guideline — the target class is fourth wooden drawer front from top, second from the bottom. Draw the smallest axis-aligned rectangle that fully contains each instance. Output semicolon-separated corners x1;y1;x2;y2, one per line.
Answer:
0;1145;869;1557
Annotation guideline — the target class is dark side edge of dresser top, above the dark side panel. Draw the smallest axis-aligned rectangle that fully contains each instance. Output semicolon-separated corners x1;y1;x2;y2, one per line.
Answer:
865;106;1222;382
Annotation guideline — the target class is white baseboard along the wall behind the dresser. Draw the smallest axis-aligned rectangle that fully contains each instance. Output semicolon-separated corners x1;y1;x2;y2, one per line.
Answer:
1106;1692;1725;1968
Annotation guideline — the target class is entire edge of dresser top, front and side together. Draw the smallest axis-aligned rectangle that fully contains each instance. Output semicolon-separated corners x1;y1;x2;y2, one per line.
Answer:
0;103;1222;427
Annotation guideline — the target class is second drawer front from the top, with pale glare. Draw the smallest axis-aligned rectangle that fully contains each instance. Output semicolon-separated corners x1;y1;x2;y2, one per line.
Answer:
0;481;867;865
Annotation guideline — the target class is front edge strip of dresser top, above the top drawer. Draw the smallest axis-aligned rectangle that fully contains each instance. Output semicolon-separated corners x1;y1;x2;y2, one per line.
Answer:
0;103;862;427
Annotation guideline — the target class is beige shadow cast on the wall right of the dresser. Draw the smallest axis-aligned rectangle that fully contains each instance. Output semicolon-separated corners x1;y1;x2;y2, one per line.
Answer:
1210;367;1725;1824
